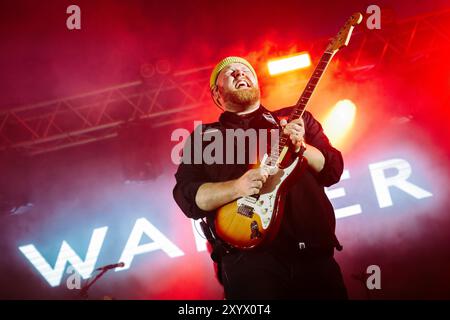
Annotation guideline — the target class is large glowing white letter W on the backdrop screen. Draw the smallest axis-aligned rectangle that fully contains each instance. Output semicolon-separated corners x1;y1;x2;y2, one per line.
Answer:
19;227;108;287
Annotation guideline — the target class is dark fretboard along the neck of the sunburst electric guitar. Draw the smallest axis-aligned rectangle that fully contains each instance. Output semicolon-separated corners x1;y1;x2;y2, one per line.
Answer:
268;51;334;165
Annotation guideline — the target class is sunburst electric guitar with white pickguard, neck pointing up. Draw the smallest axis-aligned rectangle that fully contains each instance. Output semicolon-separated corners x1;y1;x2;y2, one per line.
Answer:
215;13;362;249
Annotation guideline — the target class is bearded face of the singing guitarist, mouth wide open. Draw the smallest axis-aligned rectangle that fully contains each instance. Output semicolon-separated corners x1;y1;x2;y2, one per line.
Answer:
217;63;260;112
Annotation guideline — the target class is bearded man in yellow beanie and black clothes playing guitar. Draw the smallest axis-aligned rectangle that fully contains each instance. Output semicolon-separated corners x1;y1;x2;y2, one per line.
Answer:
174;57;347;299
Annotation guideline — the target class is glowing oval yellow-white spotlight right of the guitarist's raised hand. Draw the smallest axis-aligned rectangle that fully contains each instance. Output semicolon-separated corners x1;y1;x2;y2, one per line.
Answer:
323;99;356;146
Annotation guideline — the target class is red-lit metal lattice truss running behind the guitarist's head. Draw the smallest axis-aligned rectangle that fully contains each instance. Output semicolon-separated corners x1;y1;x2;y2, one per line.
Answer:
0;10;450;155
